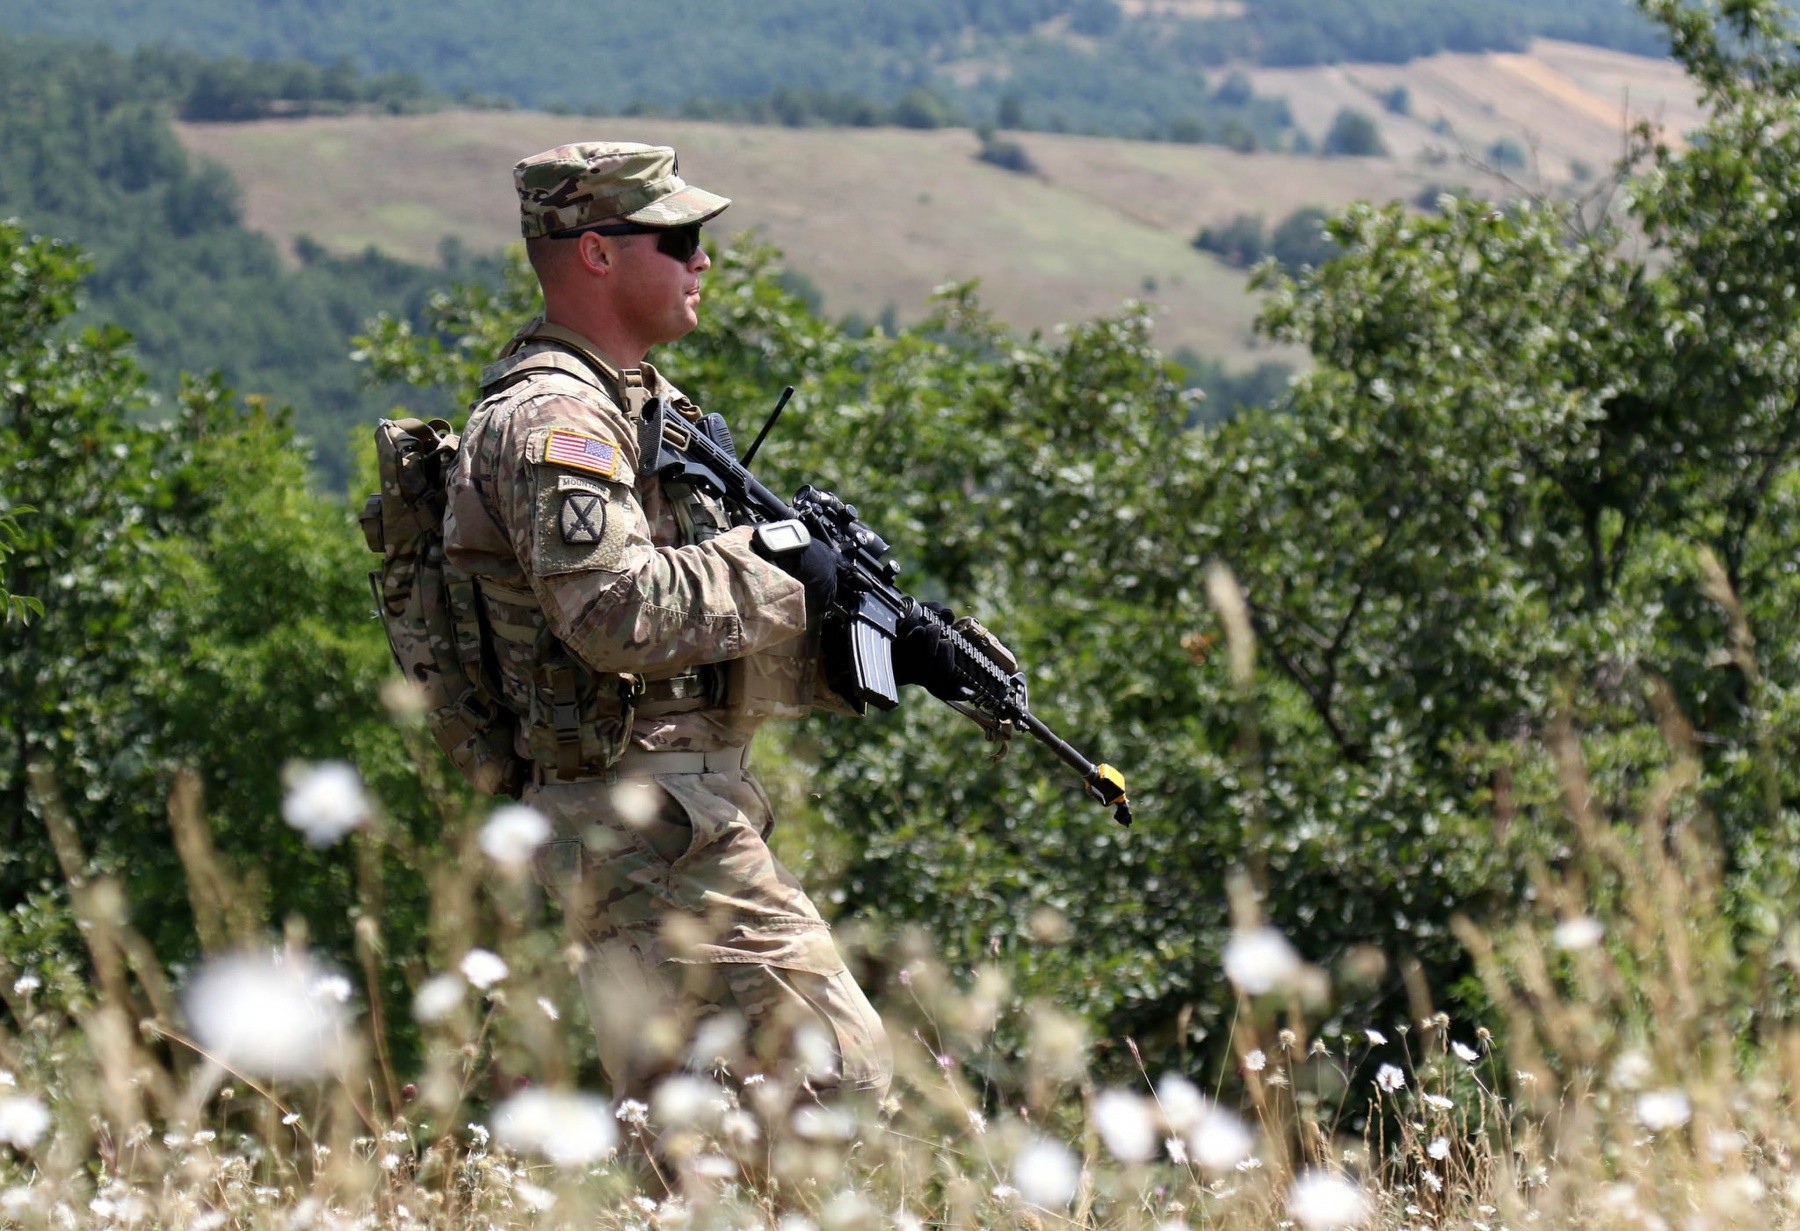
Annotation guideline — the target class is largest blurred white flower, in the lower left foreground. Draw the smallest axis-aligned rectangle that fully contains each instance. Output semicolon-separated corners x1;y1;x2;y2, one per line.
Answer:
182;954;347;1078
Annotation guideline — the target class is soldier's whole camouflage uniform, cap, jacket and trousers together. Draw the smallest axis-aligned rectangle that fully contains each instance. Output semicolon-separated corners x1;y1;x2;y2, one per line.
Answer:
445;144;891;1096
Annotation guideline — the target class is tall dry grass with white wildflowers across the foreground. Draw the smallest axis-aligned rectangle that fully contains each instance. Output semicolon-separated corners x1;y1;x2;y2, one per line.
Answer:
0;561;1800;1231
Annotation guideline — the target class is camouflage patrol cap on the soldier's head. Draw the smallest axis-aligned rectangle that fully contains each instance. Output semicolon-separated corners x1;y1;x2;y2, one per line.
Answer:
513;140;731;239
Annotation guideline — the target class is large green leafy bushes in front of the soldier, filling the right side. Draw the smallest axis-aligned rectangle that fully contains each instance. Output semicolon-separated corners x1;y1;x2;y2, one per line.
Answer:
347;0;1800;1079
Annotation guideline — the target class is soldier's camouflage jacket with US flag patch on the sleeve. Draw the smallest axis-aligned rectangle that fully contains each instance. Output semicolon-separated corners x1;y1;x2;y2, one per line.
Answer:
445;322;817;763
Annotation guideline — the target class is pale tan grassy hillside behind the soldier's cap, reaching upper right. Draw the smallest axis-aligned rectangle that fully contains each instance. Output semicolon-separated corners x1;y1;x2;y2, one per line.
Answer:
180;41;1696;365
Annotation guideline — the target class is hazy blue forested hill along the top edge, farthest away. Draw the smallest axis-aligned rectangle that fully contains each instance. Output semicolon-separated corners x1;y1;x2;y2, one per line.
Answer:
0;0;1667;139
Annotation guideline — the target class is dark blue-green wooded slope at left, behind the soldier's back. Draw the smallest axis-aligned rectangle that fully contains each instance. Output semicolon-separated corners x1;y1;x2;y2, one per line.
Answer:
0;32;482;479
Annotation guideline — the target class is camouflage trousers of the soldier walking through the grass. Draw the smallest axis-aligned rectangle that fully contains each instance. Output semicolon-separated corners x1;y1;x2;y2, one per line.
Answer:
524;772;893;1098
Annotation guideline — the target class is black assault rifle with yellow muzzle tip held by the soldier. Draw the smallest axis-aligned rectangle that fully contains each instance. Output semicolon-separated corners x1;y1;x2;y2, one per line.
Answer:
637;389;1130;824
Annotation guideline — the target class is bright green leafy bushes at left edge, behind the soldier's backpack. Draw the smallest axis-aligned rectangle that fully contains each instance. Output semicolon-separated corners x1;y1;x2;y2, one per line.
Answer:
0;223;418;986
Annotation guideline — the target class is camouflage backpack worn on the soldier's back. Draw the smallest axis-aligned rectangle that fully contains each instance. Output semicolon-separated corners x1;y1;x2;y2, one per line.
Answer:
360;419;529;795
